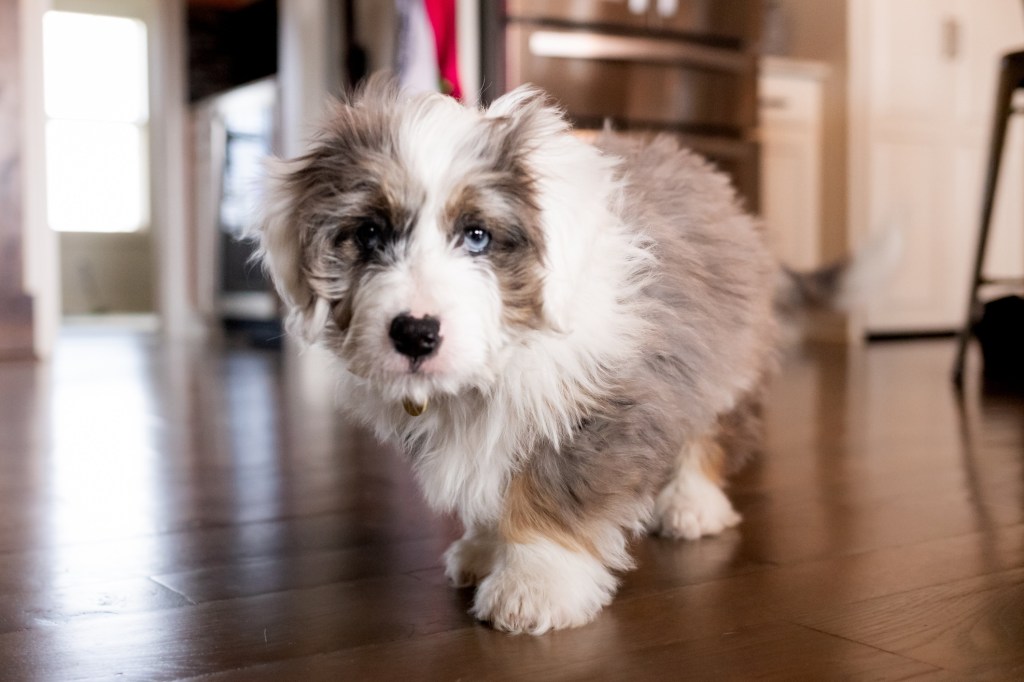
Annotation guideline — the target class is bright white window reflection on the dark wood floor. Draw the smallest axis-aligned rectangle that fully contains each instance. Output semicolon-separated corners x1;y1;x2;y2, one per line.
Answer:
46;332;163;546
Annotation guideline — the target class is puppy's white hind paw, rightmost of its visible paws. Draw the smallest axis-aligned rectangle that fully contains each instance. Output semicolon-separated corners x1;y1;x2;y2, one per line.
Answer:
655;464;741;540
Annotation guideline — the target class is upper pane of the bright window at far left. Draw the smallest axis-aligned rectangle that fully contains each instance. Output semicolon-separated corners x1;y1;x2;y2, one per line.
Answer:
43;11;148;123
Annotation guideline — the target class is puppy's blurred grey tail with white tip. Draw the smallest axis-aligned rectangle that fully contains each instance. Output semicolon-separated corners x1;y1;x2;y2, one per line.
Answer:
775;228;903;316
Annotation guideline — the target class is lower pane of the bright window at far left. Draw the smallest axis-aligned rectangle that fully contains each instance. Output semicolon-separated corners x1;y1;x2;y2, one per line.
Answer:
46;121;150;232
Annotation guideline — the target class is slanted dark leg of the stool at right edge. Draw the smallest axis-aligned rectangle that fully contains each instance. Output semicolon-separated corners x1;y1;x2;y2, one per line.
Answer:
953;58;1020;388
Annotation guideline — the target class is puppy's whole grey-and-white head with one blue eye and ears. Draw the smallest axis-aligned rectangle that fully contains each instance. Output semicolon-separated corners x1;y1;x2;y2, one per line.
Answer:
261;79;596;402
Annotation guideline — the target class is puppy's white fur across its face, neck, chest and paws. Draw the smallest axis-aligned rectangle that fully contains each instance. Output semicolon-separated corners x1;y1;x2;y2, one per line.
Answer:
256;82;767;634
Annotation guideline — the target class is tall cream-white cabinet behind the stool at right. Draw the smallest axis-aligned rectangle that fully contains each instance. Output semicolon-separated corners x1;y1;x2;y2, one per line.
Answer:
848;0;1024;333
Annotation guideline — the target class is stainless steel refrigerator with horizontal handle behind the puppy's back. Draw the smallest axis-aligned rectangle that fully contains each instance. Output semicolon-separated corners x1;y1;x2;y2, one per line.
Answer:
483;0;762;210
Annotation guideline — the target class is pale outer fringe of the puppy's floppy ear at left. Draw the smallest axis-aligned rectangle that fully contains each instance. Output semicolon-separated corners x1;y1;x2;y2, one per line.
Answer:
257;159;330;343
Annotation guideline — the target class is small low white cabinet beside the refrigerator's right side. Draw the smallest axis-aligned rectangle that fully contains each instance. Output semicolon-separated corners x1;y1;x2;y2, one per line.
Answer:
758;57;828;269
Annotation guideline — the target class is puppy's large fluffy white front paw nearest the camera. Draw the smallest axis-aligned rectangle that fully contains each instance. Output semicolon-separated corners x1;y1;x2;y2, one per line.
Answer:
471;541;617;635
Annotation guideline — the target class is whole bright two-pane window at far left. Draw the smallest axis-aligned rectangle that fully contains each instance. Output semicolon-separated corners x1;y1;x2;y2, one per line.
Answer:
43;11;150;232
